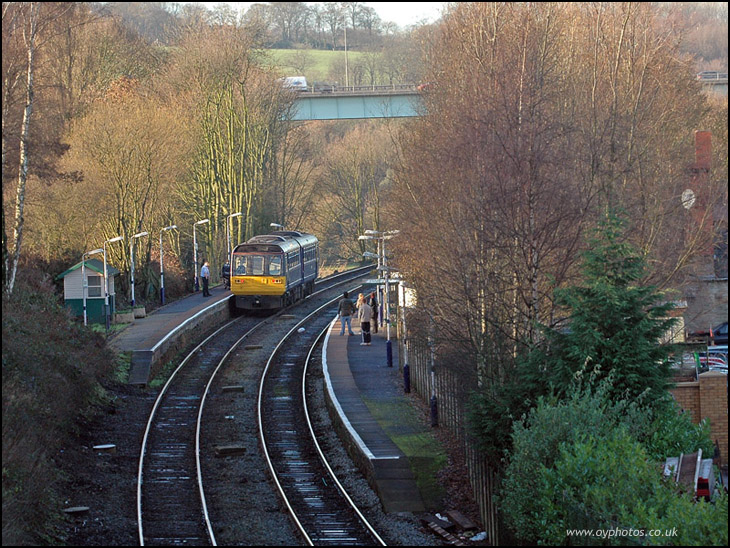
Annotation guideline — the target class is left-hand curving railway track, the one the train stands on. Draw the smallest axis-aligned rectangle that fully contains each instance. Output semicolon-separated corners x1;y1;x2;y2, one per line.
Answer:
137;269;376;545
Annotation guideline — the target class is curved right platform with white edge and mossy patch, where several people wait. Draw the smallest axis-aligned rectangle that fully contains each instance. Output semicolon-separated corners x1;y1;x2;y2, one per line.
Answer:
322;319;425;512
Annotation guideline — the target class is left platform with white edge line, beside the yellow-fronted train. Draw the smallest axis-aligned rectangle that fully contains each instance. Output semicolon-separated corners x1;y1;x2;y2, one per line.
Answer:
109;284;231;386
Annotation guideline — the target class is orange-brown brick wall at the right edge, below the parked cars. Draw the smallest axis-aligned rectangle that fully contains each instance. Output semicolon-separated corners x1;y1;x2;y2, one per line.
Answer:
672;371;728;465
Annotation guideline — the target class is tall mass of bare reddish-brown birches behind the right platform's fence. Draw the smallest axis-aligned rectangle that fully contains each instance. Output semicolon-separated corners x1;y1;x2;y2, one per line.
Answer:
392;3;703;383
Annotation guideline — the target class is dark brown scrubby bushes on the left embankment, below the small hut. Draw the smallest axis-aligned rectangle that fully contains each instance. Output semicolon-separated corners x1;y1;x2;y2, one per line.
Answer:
2;270;114;546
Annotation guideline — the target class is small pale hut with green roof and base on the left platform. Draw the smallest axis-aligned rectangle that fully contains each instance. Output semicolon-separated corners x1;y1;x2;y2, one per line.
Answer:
56;259;119;323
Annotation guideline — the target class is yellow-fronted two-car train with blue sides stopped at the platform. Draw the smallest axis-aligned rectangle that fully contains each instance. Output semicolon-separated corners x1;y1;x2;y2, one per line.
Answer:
230;231;319;313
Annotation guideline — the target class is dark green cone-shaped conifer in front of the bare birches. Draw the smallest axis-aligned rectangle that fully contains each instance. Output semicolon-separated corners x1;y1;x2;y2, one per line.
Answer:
530;214;676;404
